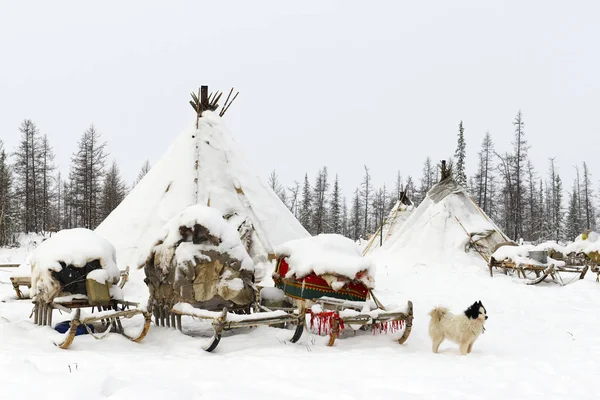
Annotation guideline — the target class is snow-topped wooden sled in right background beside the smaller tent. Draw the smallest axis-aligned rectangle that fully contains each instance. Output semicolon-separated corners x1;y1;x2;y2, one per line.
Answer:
488;242;589;285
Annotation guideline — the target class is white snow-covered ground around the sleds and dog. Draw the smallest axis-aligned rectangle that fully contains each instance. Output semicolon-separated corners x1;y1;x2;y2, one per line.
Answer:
0;239;600;400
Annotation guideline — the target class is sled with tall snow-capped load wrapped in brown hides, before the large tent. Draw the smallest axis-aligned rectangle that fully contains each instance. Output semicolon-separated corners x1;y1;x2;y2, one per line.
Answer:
143;205;302;351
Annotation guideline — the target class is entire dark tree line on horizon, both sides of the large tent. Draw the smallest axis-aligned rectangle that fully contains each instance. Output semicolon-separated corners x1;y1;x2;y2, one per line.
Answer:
0;111;600;246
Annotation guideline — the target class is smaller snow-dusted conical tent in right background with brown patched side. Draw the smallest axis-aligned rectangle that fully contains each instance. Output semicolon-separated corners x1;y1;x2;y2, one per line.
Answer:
375;177;510;265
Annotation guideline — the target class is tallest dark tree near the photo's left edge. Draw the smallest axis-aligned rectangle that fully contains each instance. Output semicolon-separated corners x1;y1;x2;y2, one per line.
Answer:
13;119;42;232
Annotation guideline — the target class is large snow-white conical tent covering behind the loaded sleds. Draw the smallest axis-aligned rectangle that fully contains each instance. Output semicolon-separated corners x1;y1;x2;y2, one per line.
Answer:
96;111;309;288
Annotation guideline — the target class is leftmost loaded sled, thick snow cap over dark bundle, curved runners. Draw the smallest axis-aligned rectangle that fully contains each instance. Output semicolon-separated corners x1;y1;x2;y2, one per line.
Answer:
29;228;151;349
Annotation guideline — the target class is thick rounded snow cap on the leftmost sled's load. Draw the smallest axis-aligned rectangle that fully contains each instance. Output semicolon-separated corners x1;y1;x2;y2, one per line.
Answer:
27;228;120;300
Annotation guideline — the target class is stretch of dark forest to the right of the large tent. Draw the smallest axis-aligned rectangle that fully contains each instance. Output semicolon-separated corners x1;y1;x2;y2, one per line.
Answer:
269;110;600;243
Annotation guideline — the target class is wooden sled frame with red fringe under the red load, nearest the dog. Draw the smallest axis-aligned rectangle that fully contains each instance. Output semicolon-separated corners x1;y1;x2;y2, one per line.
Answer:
307;292;414;346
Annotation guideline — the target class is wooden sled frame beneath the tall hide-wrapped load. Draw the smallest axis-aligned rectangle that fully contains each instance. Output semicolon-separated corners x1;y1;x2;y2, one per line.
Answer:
152;303;305;352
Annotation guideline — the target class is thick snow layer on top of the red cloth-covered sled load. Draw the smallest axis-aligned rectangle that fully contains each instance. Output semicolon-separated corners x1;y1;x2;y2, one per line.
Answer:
275;234;375;281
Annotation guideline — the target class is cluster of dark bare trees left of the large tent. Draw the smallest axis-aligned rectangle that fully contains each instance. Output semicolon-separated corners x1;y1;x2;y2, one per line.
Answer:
0;119;150;246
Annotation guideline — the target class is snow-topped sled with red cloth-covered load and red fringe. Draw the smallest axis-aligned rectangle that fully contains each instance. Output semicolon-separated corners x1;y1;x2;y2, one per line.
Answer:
273;234;413;346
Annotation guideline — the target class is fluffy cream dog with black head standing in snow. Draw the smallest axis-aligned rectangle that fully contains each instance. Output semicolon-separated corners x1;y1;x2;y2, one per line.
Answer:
429;301;488;355
